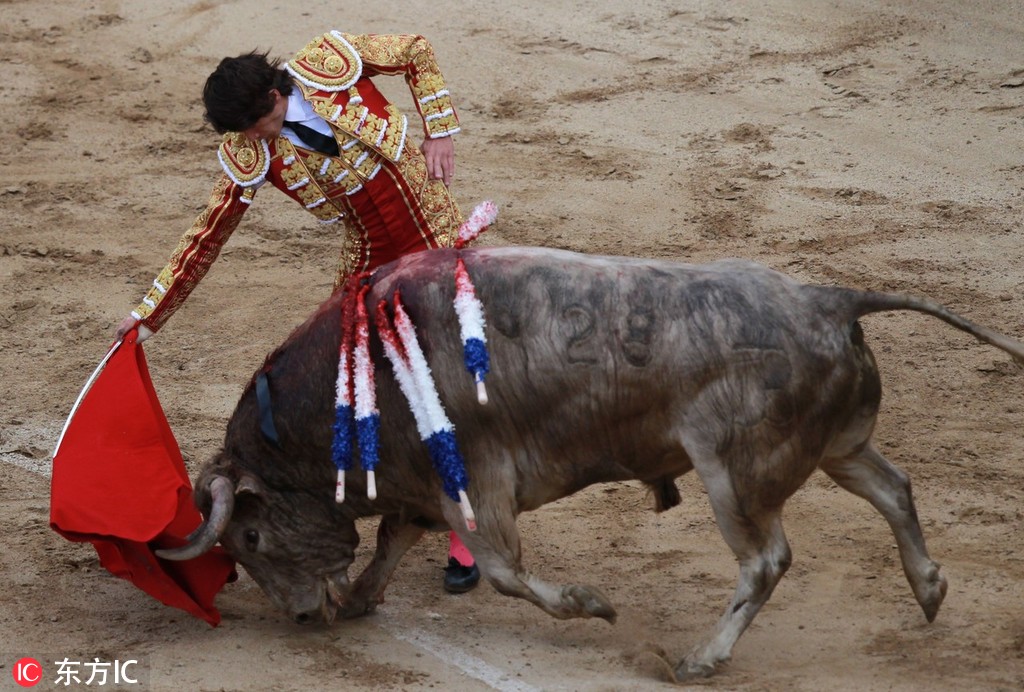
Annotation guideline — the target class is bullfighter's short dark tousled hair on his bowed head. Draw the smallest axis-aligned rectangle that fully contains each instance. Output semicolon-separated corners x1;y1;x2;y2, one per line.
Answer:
203;50;293;134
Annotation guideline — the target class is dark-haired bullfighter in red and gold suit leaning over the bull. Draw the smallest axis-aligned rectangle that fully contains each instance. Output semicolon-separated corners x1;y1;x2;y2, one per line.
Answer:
117;31;480;593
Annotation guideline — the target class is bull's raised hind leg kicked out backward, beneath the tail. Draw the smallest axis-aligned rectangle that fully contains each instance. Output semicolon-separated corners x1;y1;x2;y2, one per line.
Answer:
821;444;946;622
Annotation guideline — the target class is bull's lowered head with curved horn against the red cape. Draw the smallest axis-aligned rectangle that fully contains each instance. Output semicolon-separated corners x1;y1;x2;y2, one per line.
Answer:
157;458;359;624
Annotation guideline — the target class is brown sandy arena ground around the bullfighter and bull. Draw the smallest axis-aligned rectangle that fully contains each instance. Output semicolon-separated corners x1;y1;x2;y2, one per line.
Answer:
6;0;1024;691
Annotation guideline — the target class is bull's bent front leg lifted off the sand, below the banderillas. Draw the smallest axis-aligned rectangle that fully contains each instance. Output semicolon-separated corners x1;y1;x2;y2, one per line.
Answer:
444;500;615;622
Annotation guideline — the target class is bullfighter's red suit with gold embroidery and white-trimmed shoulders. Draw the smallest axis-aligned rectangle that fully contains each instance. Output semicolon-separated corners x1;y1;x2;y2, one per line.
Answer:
132;31;462;332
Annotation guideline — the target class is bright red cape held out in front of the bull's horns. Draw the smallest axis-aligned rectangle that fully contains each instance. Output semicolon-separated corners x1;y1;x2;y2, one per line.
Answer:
50;330;237;625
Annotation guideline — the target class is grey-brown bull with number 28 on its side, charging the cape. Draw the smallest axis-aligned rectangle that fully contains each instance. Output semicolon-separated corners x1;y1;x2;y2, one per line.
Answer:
155;248;1024;680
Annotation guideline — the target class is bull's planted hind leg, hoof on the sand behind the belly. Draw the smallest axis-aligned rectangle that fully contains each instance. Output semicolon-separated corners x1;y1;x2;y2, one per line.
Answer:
676;487;792;682
